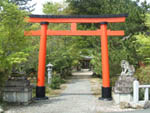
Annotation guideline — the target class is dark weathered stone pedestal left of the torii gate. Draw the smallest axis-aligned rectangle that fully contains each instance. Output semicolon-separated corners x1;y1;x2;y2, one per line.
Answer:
3;77;32;104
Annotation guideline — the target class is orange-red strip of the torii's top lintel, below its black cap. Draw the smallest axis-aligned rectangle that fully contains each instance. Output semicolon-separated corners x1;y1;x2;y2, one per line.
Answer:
27;17;126;23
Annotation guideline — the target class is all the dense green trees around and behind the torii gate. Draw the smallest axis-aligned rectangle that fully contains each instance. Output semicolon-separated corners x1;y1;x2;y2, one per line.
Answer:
0;0;150;89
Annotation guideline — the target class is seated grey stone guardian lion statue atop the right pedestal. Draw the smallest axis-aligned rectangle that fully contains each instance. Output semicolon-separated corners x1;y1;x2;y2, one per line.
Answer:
121;60;135;76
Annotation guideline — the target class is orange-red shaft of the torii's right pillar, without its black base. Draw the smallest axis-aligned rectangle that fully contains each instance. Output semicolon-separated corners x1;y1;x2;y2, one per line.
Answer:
100;24;110;87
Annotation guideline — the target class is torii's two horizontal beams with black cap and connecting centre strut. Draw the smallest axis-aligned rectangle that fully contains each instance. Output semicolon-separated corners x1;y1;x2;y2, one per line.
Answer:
25;14;128;36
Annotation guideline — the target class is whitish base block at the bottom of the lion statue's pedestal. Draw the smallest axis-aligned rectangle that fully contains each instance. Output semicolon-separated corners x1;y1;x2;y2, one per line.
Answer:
113;93;133;104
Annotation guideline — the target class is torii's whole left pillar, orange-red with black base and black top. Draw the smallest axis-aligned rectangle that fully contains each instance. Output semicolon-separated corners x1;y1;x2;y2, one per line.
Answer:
36;22;48;99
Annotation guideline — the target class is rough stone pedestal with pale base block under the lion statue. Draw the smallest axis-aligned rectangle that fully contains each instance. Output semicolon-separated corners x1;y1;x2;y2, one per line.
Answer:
113;76;136;104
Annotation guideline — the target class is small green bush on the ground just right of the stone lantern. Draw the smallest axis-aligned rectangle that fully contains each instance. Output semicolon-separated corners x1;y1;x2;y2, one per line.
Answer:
50;74;62;89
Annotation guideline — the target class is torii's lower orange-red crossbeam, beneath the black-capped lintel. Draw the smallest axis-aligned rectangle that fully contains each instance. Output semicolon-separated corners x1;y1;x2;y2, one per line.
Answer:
24;28;124;36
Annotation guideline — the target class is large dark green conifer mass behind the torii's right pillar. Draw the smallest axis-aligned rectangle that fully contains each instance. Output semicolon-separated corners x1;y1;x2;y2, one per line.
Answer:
65;0;149;77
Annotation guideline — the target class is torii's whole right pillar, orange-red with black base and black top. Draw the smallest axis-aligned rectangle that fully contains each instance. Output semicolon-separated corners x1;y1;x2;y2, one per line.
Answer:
100;22;112;100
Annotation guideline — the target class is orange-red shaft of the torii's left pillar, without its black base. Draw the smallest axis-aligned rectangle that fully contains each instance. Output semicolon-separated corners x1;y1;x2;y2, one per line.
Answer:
37;24;47;87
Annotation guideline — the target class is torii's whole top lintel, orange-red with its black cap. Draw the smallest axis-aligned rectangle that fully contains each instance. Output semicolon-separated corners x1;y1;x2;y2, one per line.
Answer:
28;14;128;23
